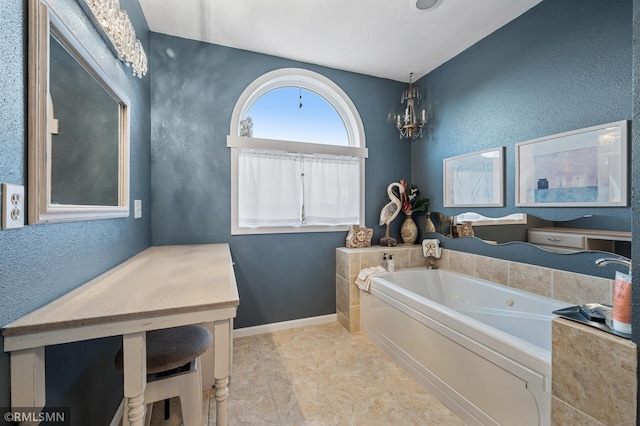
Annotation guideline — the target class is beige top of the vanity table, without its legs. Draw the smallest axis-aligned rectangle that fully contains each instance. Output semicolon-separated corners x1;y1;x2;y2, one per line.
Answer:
2;244;239;332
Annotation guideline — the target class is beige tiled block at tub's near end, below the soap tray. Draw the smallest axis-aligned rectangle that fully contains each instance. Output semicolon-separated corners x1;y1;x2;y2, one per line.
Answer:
551;319;638;426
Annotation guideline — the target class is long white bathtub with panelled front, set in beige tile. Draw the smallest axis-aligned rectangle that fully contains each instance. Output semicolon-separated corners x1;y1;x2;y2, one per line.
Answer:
360;268;570;426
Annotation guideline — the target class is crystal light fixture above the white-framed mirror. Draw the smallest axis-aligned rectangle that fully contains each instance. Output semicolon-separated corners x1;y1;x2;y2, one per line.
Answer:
80;0;147;78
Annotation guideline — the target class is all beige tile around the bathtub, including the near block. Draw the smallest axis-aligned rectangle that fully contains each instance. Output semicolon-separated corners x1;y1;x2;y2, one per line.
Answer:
336;247;638;426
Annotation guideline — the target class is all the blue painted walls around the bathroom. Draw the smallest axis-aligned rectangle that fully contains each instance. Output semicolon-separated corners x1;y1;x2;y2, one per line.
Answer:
0;0;640;424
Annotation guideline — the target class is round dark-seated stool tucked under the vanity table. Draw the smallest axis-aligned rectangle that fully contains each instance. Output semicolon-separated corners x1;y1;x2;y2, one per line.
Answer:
115;325;213;426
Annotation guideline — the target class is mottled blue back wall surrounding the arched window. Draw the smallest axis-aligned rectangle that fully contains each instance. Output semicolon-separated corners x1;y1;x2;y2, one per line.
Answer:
151;33;410;327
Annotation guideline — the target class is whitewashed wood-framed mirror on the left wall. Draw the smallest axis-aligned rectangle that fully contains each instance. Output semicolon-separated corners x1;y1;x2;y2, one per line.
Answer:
28;0;129;224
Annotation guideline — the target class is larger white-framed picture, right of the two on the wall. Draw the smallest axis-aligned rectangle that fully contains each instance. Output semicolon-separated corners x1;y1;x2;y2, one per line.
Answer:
515;120;629;207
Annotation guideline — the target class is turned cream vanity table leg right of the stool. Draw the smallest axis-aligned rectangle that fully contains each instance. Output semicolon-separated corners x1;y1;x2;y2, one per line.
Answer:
213;319;233;426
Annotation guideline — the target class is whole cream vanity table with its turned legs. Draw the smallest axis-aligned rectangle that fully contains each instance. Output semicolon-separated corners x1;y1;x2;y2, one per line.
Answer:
2;244;239;424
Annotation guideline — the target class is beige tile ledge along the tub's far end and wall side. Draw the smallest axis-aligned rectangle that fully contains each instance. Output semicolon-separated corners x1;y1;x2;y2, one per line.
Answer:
336;244;613;332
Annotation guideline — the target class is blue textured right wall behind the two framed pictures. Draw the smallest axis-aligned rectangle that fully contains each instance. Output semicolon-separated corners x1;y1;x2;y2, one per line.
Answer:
412;0;632;276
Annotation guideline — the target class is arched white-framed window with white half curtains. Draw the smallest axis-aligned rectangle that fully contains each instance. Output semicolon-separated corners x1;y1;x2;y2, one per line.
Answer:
227;69;367;234
